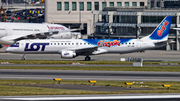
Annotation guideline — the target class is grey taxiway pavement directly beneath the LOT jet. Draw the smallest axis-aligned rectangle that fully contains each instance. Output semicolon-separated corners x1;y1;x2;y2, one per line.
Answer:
0;50;180;61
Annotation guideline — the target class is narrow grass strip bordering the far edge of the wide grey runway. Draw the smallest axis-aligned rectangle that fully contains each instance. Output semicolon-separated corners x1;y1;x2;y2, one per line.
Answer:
0;66;180;72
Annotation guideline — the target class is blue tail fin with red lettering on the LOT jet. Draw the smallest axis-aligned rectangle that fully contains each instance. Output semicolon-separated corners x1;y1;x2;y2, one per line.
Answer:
142;16;172;40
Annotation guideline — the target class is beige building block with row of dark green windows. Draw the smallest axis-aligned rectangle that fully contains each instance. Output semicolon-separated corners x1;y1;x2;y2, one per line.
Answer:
45;0;147;35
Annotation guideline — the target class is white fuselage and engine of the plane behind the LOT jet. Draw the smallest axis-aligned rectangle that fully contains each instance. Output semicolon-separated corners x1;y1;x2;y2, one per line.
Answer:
0;22;72;44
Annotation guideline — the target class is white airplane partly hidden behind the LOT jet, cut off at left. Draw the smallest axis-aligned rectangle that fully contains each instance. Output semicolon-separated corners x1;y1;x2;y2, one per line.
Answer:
0;22;83;48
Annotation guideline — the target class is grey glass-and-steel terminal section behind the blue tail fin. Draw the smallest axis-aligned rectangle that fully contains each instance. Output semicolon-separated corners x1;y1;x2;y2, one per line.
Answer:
90;7;180;50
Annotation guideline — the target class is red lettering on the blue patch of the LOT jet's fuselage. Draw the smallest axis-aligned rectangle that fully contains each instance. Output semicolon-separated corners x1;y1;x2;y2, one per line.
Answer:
97;40;120;47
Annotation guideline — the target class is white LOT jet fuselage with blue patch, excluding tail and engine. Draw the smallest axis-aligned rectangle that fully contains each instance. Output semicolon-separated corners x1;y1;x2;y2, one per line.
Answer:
6;39;155;55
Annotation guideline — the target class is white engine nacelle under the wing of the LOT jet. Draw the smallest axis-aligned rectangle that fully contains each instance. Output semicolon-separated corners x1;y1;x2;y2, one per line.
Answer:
61;51;76;59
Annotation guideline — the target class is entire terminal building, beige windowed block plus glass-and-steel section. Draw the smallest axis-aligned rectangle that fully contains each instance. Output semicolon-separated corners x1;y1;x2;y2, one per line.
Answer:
45;0;180;50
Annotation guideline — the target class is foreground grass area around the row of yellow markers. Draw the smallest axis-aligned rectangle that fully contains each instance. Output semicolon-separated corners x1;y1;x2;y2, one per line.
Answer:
0;79;180;96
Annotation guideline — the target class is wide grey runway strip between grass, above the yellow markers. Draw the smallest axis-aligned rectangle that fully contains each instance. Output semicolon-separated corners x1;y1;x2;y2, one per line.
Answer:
0;69;180;81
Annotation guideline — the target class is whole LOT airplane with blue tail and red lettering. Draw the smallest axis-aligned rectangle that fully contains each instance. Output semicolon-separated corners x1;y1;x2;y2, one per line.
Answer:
6;16;172;61
